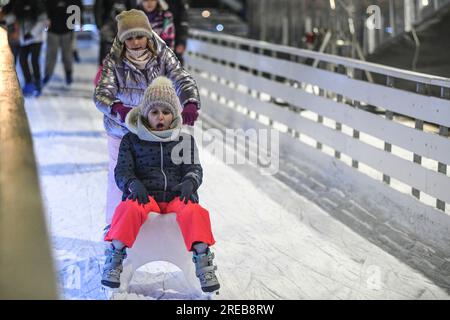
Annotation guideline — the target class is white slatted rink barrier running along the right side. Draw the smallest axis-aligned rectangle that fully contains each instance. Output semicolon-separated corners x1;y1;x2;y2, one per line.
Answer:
186;30;450;216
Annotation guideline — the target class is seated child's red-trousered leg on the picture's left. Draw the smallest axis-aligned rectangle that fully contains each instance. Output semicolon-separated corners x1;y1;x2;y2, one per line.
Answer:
105;197;160;248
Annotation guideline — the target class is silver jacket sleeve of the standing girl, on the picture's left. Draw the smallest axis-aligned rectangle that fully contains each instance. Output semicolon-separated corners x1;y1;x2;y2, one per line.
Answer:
94;54;120;119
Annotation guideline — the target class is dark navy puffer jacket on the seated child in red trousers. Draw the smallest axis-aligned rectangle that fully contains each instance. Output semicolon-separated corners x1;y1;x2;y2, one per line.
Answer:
114;109;203;202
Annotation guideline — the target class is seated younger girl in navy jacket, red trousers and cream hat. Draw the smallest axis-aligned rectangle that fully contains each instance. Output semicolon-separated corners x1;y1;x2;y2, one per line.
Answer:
102;77;220;292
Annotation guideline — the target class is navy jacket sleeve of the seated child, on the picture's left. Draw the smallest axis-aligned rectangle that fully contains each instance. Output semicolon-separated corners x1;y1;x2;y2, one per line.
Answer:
114;133;137;194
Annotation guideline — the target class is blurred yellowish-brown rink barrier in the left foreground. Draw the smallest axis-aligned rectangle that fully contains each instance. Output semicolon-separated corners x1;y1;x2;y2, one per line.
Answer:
0;28;57;300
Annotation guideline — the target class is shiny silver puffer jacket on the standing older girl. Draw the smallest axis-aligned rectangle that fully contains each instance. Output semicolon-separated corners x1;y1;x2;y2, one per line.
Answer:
94;33;200;138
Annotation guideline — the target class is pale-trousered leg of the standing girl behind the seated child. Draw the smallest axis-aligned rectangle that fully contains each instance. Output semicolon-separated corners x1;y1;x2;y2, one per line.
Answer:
106;135;123;224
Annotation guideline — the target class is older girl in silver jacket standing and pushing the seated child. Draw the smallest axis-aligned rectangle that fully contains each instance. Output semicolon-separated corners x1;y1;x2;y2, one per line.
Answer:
94;9;200;224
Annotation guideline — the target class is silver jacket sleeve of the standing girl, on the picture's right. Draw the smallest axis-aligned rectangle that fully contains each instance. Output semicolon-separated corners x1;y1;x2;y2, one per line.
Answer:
161;40;201;109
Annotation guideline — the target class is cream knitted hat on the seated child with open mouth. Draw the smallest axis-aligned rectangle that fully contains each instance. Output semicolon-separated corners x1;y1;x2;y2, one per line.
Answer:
139;76;181;118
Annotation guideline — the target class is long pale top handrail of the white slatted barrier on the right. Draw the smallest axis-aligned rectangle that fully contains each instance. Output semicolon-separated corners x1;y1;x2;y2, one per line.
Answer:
189;29;450;88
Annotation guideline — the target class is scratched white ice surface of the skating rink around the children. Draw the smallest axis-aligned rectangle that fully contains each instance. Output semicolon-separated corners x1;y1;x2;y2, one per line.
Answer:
25;42;449;300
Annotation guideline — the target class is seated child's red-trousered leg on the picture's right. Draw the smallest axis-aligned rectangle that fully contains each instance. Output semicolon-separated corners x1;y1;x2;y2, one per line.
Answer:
164;197;216;251
